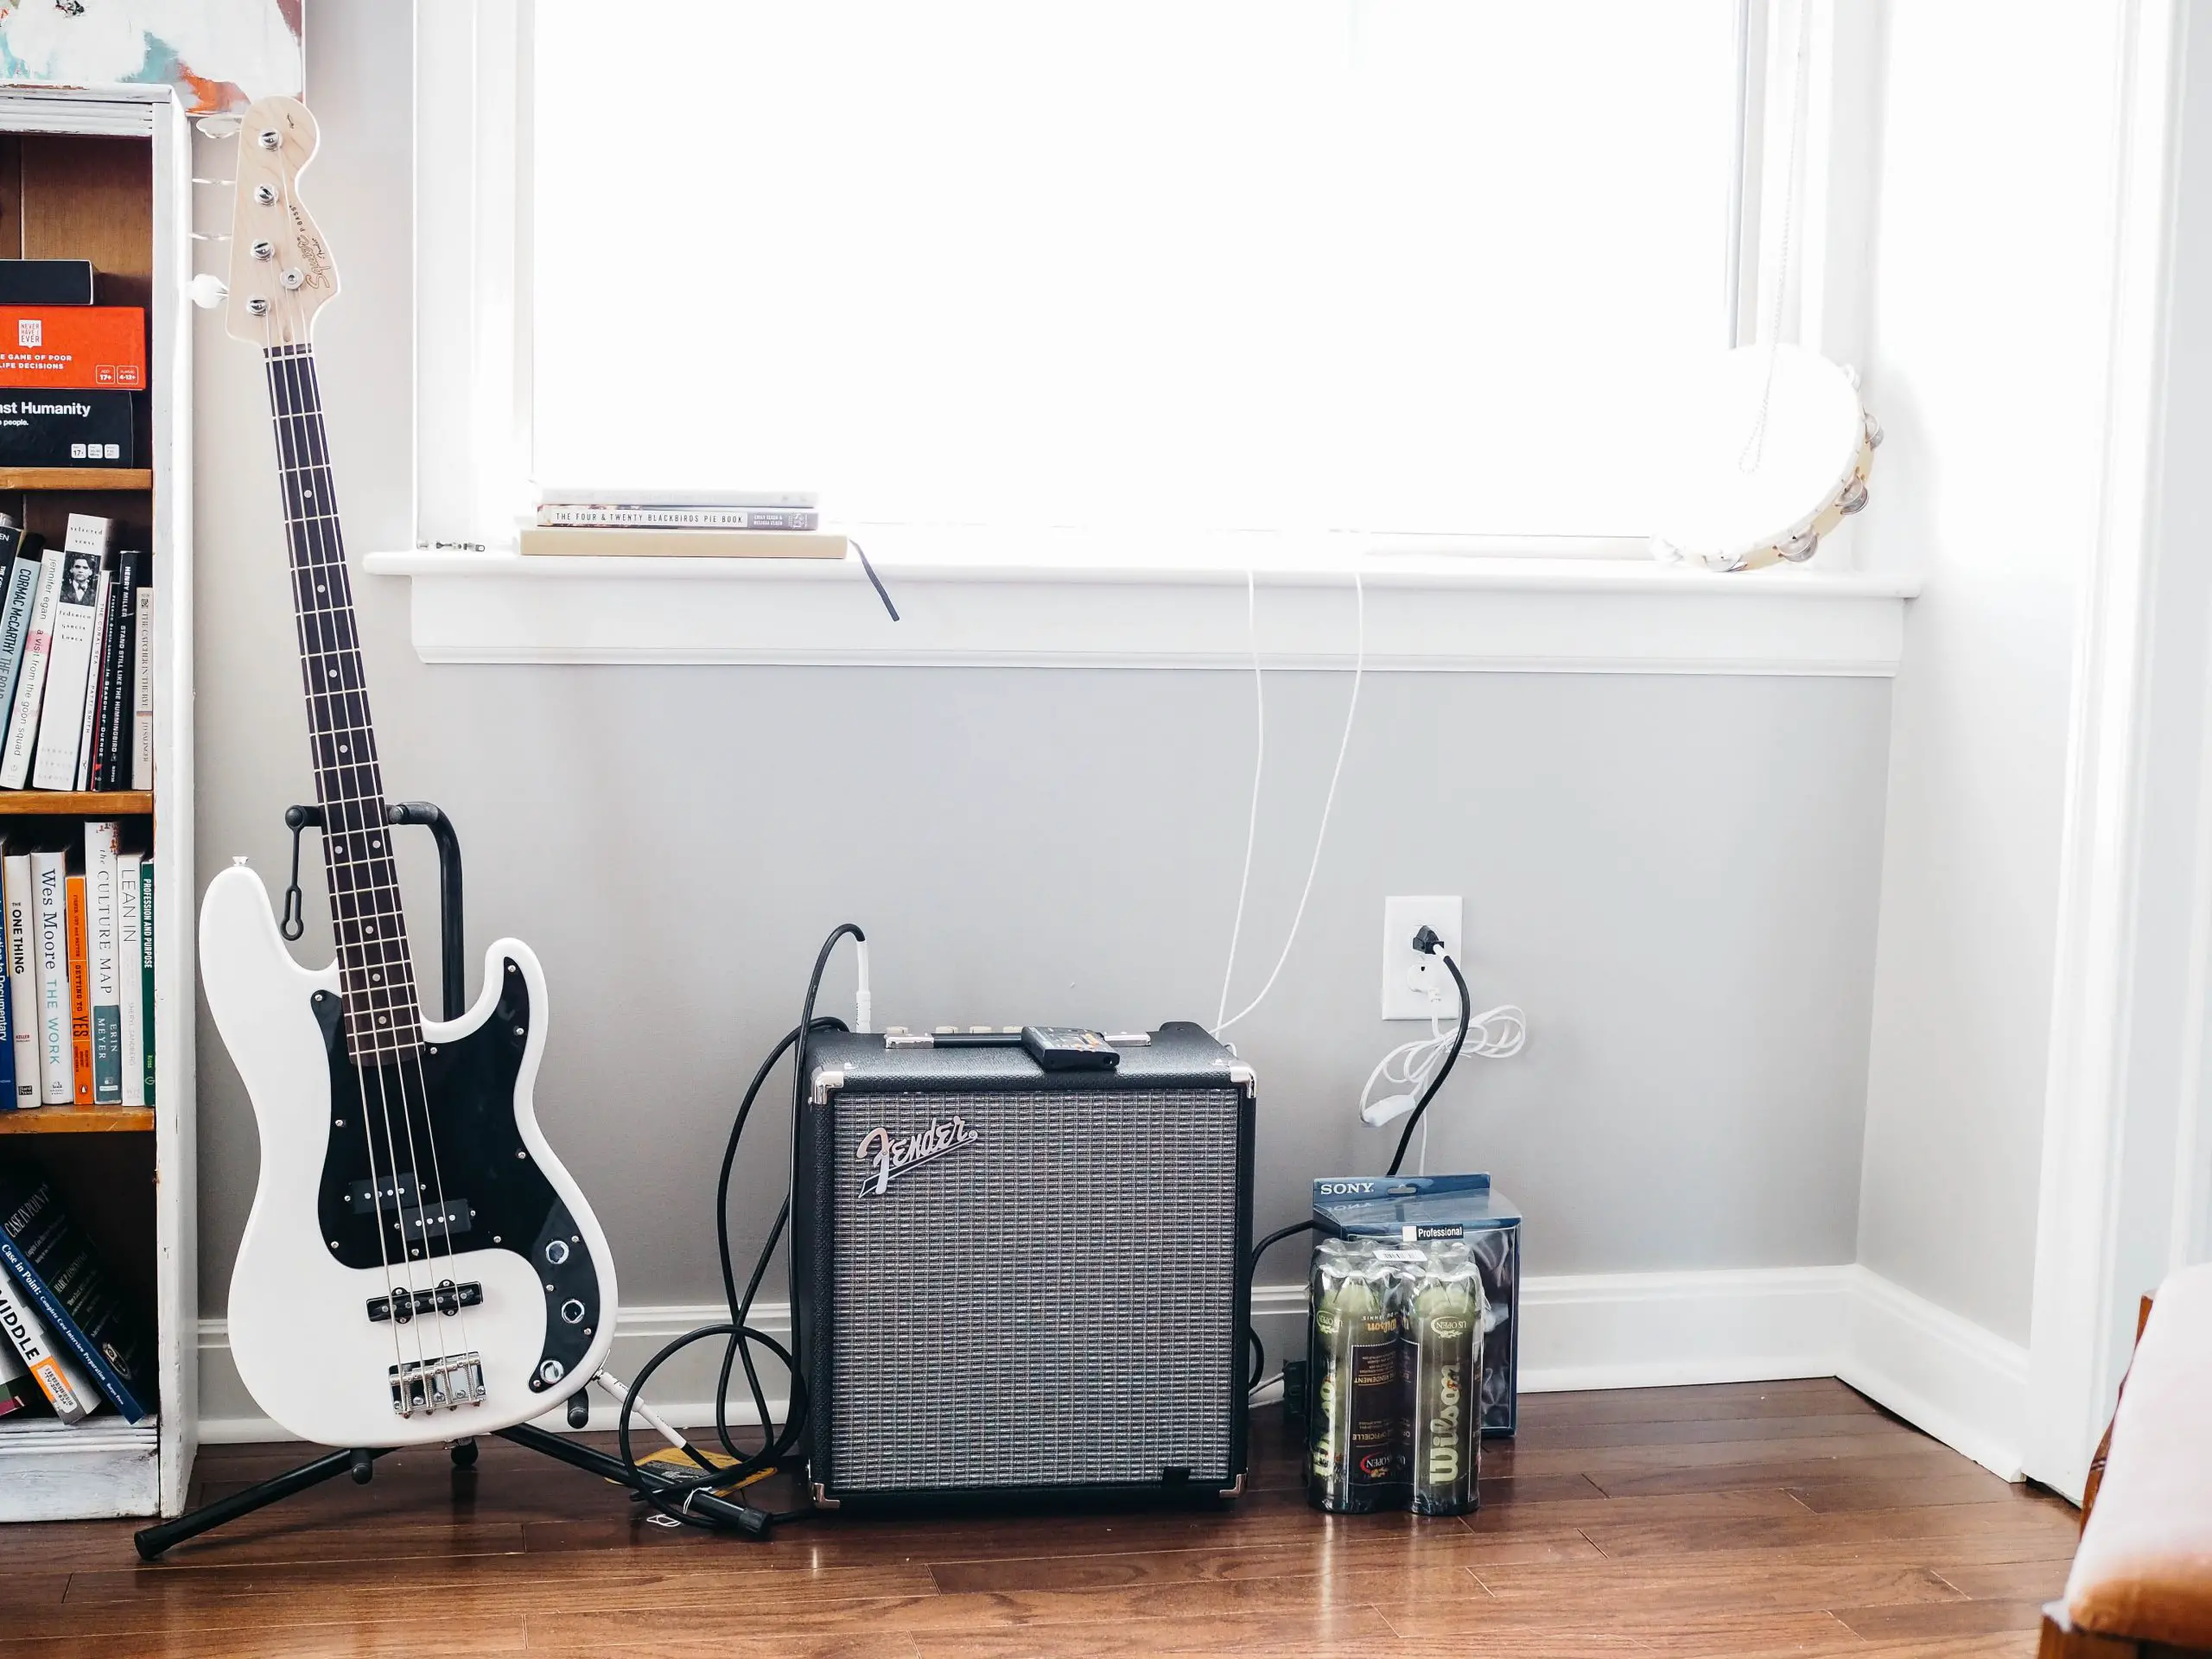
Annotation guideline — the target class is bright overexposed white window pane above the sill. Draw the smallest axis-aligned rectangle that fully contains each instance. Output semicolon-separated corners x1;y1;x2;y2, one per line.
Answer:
533;0;1737;536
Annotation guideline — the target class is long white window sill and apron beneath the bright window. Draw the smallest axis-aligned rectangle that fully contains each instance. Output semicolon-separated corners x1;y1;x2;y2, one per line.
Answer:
367;531;1918;677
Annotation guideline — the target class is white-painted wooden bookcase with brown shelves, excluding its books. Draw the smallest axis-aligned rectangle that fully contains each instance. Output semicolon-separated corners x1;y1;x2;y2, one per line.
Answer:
0;84;199;1553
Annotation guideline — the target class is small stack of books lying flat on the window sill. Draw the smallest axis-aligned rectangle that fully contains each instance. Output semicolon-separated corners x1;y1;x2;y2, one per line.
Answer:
522;489;845;560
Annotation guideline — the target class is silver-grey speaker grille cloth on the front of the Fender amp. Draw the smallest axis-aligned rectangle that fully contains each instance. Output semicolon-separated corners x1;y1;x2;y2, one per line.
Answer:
830;1089;1243;1493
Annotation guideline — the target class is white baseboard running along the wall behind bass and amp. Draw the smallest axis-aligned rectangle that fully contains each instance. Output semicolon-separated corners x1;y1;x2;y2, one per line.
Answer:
199;1268;2029;1480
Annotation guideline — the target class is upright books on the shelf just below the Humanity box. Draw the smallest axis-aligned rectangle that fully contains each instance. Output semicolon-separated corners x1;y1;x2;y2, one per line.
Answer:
0;513;153;790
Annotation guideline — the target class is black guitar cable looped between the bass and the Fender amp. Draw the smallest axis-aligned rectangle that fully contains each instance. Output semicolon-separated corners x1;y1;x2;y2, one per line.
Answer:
615;923;868;1537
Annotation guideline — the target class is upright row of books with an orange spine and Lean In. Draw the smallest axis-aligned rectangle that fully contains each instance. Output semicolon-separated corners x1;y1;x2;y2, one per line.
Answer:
0;818;155;1110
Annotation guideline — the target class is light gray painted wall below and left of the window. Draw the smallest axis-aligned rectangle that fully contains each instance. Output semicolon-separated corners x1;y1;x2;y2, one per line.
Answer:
197;0;1889;1314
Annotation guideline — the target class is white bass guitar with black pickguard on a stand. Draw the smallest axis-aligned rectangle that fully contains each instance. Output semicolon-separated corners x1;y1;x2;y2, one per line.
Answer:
199;98;617;1446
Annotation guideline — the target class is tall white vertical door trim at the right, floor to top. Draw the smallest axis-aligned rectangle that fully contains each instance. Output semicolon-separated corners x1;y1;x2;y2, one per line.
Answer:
2019;0;2203;1500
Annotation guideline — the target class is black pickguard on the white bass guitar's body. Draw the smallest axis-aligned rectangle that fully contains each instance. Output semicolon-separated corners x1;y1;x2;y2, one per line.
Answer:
315;960;601;1394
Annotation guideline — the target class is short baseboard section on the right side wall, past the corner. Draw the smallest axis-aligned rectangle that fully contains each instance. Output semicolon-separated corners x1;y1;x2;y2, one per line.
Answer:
1836;1268;2029;1480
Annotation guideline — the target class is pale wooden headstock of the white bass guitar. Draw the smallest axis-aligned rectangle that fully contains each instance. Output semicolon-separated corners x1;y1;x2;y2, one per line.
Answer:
228;98;339;347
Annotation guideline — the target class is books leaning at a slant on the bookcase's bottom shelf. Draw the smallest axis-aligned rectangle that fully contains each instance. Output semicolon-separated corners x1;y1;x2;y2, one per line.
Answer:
0;1164;155;1422
